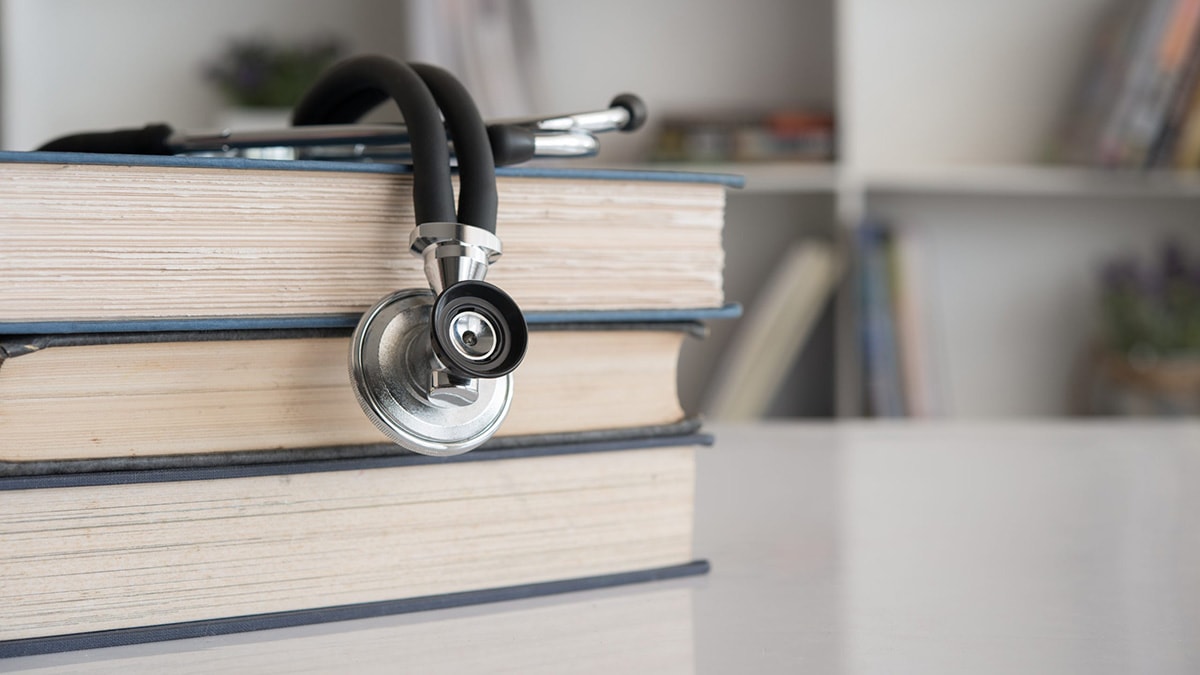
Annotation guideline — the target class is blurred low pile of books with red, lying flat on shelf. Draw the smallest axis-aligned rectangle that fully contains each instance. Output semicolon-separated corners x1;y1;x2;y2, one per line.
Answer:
650;109;834;162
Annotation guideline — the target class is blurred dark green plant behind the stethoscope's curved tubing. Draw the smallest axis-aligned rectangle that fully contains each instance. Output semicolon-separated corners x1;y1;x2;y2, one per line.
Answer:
205;36;342;107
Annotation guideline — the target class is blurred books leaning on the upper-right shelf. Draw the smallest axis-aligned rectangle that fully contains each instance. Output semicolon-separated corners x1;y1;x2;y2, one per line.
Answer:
1050;0;1200;169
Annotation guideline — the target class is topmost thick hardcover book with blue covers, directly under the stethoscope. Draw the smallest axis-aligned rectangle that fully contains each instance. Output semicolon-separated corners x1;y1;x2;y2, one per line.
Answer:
0;153;738;333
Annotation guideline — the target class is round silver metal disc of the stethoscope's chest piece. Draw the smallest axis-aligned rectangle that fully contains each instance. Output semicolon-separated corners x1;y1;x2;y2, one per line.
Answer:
350;289;512;456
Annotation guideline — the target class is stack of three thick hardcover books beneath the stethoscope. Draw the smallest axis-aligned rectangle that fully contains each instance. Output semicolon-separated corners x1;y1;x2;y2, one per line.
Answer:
0;153;736;656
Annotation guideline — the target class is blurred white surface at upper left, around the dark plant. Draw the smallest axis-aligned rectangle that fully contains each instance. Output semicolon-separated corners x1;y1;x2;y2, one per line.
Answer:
0;0;404;150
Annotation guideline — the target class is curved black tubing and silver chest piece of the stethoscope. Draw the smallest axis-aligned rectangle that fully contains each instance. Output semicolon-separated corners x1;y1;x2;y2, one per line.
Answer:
293;56;528;456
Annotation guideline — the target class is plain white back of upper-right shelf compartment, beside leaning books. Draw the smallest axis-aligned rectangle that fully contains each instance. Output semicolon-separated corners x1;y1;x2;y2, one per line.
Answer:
838;0;1112;168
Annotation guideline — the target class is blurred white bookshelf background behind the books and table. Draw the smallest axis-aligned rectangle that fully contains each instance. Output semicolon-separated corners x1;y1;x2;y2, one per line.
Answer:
7;0;1200;419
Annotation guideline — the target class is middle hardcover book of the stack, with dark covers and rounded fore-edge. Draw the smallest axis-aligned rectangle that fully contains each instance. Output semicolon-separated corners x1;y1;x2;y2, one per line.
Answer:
0;312;727;476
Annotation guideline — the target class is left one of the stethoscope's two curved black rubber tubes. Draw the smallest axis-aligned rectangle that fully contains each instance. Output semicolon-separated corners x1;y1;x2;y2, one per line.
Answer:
292;55;456;225
